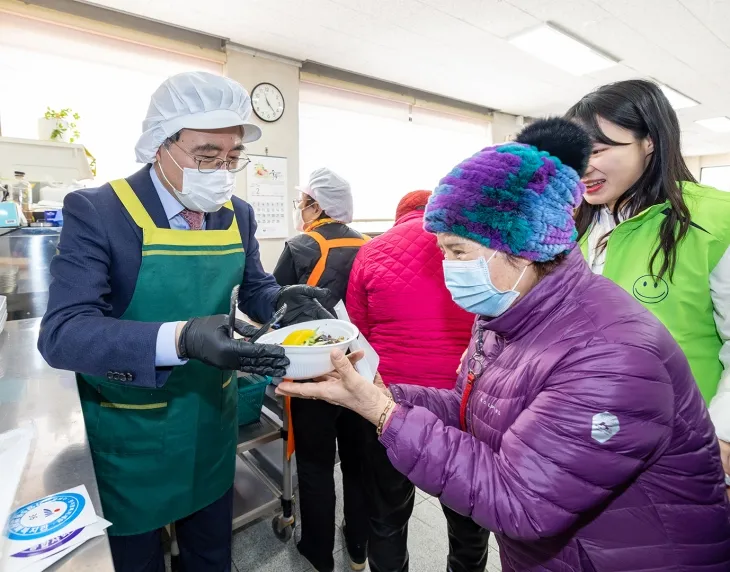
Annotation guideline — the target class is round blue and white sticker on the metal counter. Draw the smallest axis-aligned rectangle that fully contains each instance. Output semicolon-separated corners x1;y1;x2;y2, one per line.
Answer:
8;493;86;540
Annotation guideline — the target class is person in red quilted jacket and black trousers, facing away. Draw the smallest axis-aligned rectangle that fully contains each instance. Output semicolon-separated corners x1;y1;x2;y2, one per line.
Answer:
346;191;489;572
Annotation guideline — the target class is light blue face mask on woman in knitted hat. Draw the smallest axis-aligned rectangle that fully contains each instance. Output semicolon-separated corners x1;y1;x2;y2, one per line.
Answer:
444;252;527;318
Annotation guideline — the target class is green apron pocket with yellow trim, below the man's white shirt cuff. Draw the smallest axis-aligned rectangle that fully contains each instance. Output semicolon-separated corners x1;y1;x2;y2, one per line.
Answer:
89;382;170;455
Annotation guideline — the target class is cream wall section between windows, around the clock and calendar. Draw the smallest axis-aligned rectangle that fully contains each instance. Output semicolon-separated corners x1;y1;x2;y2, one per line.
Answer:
225;47;299;272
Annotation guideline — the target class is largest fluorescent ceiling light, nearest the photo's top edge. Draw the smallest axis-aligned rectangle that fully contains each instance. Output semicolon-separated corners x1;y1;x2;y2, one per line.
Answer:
509;24;618;75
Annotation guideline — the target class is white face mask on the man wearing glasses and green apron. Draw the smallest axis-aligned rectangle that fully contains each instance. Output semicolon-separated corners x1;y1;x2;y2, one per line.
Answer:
160;148;236;213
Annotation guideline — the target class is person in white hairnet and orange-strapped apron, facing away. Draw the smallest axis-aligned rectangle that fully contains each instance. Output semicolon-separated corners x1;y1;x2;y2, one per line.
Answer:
274;168;370;572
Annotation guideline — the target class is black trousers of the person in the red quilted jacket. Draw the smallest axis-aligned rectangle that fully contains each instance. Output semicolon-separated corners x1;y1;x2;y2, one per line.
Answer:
364;427;489;572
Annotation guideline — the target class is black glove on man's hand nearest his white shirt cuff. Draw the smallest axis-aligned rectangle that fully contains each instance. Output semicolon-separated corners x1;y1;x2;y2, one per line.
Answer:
177;315;289;377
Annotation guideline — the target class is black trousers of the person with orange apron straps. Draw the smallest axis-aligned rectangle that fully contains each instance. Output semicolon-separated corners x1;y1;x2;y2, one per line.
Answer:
291;399;369;572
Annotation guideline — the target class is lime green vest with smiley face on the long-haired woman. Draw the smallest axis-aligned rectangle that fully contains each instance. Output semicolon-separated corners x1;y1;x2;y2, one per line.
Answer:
581;183;730;403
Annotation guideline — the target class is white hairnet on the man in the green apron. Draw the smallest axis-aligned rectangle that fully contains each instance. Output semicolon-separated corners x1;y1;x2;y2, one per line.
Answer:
135;72;261;163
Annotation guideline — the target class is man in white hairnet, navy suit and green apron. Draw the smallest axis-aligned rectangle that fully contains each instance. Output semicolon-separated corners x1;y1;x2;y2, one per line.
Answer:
38;72;329;572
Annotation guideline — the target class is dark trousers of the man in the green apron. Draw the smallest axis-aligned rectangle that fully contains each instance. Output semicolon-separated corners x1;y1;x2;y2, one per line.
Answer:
109;487;233;572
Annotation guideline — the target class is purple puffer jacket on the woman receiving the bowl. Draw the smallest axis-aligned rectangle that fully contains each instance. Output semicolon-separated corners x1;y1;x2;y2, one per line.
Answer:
381;250;730;572
